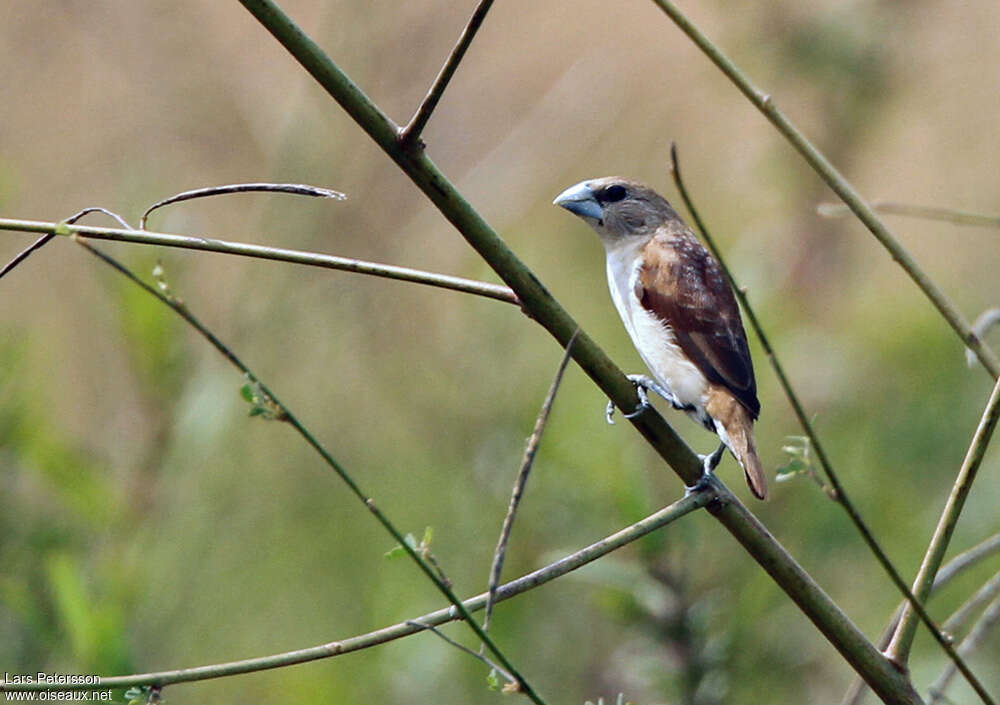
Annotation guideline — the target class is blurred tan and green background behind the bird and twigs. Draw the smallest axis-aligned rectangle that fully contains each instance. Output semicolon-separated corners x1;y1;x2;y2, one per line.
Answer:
0;0;1000;705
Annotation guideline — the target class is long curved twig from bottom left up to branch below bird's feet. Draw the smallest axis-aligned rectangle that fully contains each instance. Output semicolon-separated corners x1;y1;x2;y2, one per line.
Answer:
0;491;717;692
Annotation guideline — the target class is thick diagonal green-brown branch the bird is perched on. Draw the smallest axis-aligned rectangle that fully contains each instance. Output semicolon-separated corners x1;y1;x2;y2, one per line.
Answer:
232;0;920;704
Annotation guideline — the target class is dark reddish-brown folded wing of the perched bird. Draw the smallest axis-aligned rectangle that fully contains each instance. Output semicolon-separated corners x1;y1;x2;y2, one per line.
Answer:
636;227;760;419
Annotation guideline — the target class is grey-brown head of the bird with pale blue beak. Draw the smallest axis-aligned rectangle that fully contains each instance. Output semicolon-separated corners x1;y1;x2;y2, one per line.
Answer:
553;176;678;247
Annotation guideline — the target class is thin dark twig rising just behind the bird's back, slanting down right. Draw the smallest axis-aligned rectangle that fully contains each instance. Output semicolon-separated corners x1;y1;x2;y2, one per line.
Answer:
670;144;980;692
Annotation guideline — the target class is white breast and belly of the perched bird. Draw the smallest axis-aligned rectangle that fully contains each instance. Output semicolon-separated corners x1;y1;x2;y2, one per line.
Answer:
607;240;708;411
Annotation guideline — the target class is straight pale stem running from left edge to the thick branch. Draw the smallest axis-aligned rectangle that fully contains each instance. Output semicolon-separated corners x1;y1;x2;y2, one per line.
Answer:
0;218;520;305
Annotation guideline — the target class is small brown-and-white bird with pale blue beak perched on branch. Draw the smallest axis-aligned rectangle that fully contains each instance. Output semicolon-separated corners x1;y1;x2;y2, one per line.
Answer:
553;176;767;499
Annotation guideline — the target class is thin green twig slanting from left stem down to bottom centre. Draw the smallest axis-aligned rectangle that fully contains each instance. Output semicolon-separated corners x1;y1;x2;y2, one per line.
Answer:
71;238;545;705
